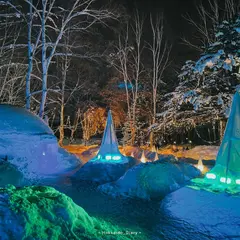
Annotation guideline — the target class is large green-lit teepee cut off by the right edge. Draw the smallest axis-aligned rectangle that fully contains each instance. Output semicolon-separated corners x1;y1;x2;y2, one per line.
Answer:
206;92;240;184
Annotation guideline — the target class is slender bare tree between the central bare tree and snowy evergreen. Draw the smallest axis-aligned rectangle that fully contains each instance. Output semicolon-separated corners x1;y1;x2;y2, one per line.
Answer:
148;14;171;147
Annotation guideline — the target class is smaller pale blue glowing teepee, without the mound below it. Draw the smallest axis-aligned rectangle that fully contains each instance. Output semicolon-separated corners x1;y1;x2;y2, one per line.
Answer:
96;111;124;161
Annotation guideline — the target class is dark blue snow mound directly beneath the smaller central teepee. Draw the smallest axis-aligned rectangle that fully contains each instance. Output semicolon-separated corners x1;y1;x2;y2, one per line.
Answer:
73;157;137;184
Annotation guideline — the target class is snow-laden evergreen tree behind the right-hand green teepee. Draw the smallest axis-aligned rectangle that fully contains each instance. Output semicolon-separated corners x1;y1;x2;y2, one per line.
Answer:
158;16;240;141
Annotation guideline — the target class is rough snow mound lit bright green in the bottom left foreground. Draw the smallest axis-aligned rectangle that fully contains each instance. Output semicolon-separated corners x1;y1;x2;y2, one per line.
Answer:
0;186;139;240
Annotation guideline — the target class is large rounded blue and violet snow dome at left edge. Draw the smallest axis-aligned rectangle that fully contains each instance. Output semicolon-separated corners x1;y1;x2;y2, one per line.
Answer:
0;104;80;185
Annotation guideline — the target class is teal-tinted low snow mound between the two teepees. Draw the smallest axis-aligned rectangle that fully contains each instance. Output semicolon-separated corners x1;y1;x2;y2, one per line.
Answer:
98;160;200;200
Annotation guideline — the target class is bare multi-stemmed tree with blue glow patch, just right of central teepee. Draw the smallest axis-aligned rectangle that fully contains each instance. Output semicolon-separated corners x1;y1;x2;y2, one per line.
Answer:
109;12;144;144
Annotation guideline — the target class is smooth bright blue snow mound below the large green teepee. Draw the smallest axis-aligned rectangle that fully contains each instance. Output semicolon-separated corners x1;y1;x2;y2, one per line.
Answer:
157;187;240;240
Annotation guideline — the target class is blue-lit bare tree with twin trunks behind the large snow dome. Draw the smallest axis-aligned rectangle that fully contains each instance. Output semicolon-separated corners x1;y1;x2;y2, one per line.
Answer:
17;0;117;117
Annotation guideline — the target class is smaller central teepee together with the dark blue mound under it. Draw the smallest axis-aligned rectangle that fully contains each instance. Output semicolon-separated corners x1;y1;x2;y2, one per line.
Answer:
73;111;137;184
